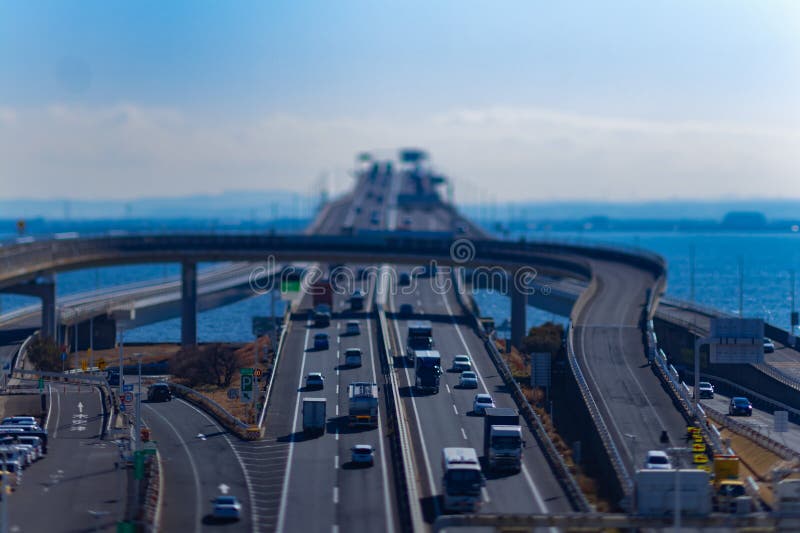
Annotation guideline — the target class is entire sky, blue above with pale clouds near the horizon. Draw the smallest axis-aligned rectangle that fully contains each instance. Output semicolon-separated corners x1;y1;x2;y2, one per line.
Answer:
0;0;800;200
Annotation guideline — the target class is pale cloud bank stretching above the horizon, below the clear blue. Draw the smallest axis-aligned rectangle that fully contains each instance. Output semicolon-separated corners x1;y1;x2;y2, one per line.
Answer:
0;104;800;200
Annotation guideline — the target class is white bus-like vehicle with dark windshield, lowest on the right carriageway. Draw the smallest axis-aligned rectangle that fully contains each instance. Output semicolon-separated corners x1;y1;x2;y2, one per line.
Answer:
442;448;486;513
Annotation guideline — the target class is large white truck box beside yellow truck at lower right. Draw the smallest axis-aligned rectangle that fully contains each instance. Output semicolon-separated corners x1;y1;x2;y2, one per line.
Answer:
634;468;712;516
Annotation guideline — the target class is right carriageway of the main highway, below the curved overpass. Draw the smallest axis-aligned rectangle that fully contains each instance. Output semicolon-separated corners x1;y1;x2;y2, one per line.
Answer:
388;266;572;520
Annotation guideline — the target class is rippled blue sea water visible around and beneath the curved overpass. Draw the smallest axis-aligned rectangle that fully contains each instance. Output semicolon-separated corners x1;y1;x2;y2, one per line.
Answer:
0;232;800;342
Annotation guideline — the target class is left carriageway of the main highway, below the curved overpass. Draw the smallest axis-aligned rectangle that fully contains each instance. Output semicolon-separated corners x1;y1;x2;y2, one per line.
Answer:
264;274;398;532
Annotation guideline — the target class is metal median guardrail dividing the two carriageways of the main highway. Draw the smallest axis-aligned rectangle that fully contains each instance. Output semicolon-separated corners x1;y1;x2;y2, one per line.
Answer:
375;302;427;532
